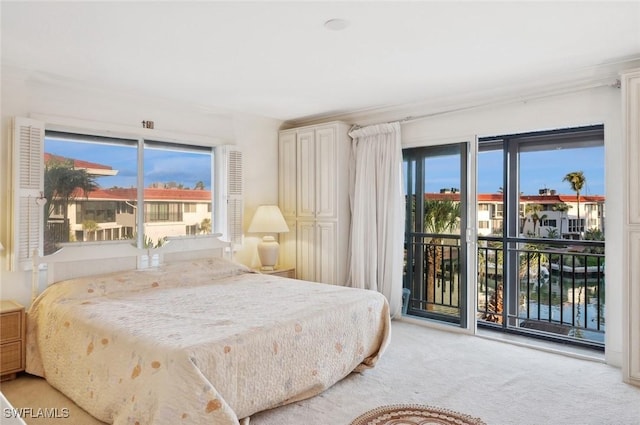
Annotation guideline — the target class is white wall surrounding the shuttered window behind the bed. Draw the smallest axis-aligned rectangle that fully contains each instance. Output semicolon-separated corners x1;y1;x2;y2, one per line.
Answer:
0;69;281;306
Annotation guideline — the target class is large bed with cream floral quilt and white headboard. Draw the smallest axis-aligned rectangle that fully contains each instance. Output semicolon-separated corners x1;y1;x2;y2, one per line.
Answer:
27;237;390;425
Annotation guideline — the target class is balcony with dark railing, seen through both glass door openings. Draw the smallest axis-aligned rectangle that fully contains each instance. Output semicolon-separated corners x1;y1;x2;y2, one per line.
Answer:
405;233;605;349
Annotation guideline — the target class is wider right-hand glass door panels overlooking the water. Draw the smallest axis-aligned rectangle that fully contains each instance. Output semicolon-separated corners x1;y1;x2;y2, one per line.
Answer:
476;125;605;348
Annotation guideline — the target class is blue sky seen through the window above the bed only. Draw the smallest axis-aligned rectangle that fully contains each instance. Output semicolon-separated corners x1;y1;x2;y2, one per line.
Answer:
45;138;211;190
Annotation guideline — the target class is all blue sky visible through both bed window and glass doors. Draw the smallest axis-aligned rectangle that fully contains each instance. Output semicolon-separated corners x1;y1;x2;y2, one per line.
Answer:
45;138;605;195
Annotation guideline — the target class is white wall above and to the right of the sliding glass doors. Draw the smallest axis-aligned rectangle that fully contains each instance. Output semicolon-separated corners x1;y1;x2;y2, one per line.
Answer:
324;85;624;366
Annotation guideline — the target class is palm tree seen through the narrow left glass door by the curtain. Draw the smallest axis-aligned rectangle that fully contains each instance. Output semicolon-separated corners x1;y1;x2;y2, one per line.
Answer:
424;200;460;309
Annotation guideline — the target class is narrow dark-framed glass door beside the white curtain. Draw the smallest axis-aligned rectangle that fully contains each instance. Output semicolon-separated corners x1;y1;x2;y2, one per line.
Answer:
403;143;468;327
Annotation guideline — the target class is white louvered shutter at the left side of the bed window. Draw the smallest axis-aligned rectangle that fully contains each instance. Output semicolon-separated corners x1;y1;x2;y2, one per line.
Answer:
9;117;44;271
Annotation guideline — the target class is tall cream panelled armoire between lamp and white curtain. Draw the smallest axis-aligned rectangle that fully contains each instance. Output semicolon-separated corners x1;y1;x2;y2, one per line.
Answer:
278;122;351;285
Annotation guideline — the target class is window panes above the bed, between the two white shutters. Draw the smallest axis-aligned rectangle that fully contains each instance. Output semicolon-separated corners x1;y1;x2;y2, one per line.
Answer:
44;131;213;253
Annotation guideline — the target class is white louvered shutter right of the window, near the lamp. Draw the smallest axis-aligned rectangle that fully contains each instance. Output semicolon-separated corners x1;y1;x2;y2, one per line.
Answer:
216;145;244;249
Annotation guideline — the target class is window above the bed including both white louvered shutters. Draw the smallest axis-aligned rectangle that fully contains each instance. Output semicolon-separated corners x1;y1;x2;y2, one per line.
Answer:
8;118;242;270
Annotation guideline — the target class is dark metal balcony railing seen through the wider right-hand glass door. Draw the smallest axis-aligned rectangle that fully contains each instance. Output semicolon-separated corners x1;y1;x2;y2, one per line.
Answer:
477;237;605;348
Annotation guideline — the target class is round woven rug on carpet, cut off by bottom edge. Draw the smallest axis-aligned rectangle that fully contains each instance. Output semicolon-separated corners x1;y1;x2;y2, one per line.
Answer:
351;404;486;425
